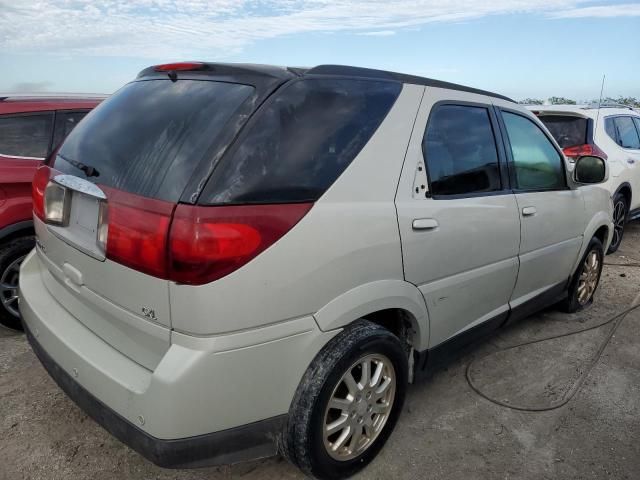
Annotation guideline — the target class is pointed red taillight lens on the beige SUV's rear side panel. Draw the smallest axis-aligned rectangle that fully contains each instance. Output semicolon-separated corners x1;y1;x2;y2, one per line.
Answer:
169;203;313;285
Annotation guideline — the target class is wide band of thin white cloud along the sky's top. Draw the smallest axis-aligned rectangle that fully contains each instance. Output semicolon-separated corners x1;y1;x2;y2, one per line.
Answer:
0;0;640;60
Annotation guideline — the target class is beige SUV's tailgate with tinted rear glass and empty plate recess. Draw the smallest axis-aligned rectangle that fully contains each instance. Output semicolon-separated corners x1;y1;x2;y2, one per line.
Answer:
36;78;254;369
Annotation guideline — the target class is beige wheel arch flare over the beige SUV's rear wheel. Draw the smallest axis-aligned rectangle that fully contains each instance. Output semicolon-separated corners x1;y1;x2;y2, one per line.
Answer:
314;280;429;350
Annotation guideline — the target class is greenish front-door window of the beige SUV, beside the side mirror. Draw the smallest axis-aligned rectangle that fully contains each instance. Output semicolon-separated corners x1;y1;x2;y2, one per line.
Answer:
502;112;566;190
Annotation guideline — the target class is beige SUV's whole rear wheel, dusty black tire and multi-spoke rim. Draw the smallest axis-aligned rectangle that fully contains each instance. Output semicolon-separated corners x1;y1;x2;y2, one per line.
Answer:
281;320;408;479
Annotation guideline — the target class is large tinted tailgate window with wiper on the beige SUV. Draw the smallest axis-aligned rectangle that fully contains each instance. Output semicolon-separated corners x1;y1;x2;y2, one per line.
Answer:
54;79;254;202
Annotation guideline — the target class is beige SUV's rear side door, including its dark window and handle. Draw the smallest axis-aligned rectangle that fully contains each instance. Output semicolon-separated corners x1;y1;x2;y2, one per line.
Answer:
396;92;520;346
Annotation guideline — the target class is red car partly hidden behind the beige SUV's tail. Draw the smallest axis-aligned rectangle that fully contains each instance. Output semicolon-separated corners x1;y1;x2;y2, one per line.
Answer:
0;95;105;329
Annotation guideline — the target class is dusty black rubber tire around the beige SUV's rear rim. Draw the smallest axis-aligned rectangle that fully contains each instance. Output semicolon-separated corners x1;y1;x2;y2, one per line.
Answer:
281;320;408;479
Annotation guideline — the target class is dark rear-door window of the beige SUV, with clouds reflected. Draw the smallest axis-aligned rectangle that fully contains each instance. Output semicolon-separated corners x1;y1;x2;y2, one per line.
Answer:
422;105;502;195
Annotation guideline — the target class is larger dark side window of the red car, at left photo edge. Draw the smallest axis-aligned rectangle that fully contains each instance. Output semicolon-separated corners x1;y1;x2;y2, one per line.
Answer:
0;113;53;159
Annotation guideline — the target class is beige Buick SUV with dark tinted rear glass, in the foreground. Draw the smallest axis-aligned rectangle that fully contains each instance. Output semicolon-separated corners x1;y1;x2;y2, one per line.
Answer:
20;63;613;478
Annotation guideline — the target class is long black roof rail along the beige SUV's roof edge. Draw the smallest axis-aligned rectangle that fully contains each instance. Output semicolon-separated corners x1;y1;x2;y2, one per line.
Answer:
305;65;516;103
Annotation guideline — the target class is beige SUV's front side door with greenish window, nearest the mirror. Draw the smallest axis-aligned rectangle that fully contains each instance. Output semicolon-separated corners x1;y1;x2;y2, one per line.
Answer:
500;108;585;308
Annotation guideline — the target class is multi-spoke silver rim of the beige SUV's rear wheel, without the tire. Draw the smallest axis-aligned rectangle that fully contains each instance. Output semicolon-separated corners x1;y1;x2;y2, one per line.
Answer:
323;354;396;461
